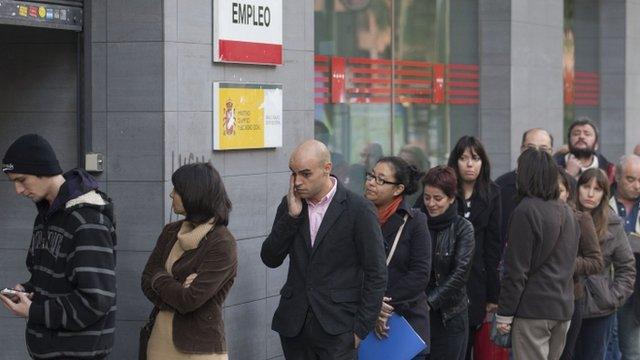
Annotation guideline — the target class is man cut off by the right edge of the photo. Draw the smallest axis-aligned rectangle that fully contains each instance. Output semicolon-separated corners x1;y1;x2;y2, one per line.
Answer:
609;155;640;360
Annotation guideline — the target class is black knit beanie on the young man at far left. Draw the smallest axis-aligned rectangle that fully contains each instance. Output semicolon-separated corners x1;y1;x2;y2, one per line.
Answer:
2;134;62;176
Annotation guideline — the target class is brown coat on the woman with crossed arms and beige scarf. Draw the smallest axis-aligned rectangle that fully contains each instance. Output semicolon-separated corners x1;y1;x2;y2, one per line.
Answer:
142;221;238;354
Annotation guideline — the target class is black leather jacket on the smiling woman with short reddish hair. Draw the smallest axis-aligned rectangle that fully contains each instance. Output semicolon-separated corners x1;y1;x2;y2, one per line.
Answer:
422;205;475;322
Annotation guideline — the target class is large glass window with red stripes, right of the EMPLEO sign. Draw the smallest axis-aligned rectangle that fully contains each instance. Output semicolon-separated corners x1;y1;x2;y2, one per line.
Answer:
315;0;479;197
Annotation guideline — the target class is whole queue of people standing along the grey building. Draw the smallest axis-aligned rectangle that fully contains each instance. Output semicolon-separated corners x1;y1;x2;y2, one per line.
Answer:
0;119;640;360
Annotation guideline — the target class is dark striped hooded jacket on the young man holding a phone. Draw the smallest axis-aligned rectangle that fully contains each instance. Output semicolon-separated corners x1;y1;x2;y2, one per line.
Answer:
22;169;116;359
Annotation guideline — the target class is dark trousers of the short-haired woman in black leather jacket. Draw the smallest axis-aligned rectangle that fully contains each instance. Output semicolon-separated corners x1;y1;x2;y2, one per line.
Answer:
427;310;469;360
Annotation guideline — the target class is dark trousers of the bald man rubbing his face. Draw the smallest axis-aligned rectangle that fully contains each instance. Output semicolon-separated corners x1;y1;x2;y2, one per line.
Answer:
280;308;358;360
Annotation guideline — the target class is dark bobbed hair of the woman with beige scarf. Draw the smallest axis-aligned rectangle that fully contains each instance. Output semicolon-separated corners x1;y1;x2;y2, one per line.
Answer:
171;163;231;226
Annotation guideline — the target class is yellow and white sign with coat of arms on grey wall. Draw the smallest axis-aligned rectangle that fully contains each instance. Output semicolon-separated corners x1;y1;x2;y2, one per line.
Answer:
213;83;282;150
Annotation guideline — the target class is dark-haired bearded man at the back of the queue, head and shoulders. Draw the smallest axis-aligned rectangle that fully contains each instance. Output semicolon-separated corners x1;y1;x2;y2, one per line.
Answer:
554;117;615;184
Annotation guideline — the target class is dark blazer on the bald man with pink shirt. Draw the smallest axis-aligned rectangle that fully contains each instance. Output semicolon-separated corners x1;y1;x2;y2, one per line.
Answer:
260;181;387;339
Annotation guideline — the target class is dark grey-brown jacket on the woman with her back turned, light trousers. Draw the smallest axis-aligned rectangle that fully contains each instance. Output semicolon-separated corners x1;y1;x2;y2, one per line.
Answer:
498;197;580;321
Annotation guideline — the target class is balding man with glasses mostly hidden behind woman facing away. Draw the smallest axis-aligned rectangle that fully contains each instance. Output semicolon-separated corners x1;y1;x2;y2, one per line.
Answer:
496;128;553;246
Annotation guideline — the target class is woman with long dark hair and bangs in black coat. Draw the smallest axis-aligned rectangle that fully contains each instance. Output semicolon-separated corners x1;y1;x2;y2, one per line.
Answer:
449;136;502;359
